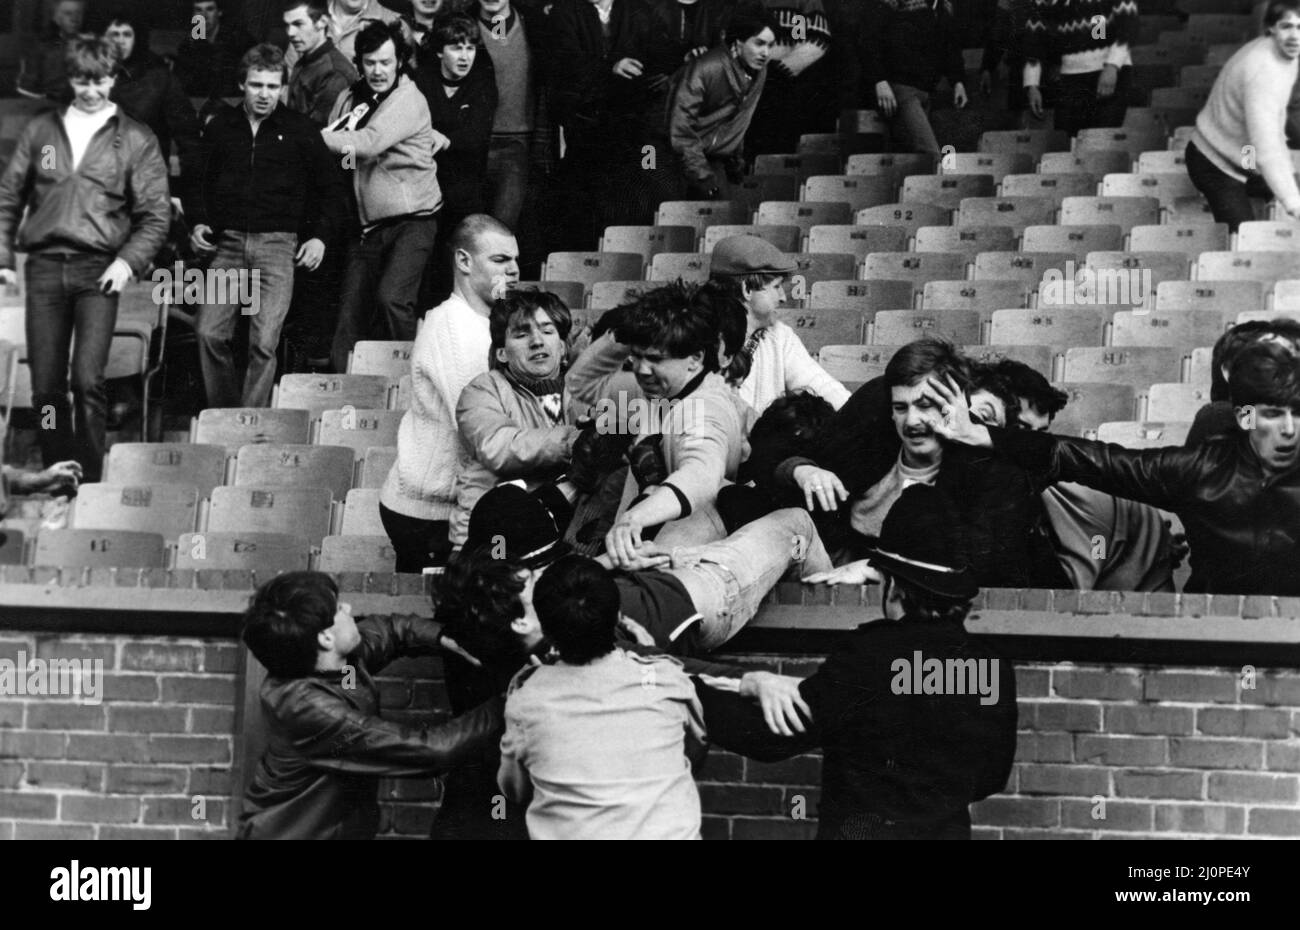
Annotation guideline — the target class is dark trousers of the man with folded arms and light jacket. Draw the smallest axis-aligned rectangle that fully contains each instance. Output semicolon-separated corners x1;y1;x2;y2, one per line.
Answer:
330;216;438;372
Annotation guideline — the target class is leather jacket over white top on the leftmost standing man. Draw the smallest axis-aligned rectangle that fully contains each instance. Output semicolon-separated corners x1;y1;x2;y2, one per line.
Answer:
0;109;172;276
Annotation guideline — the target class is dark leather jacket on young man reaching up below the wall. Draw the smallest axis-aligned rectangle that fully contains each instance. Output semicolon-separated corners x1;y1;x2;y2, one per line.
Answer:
239;615;504;839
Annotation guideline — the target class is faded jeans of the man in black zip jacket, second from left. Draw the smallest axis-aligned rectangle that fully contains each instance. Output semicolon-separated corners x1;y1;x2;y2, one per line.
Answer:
194;232;298;407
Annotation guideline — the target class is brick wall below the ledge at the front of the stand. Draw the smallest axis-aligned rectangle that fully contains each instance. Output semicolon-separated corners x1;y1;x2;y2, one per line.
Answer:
0;631;1300;839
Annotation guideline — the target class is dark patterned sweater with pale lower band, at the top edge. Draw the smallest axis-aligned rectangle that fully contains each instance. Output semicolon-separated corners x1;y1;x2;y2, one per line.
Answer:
1022;0;1138;87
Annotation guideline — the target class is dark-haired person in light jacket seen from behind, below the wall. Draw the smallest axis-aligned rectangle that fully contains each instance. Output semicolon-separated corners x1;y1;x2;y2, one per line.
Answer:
498;555;705;840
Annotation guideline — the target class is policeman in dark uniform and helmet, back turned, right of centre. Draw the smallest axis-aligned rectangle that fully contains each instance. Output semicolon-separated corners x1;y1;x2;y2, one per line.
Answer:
697;485;1018;839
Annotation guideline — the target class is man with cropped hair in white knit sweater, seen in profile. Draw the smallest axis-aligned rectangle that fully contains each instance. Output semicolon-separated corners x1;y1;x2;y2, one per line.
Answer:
380;213;519;572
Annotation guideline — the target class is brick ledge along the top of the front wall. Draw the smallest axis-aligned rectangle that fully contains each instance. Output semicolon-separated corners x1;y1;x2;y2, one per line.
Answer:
0;582;1300;669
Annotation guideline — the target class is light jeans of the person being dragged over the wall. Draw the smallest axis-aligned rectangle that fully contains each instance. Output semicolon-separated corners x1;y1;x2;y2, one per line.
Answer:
664;507;833;650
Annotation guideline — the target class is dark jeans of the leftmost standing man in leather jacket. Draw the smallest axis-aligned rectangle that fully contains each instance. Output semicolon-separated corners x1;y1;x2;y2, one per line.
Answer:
25;252;117;481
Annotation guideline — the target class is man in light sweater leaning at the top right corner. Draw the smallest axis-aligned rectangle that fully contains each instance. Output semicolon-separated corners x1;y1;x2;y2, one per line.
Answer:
1186;0;1300;233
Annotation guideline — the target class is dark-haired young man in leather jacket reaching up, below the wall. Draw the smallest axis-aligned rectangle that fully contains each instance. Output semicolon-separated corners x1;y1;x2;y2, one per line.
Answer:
239;571;503;839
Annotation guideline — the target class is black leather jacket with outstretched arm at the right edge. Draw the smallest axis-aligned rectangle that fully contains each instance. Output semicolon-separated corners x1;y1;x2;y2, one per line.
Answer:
988;427;1300;596
